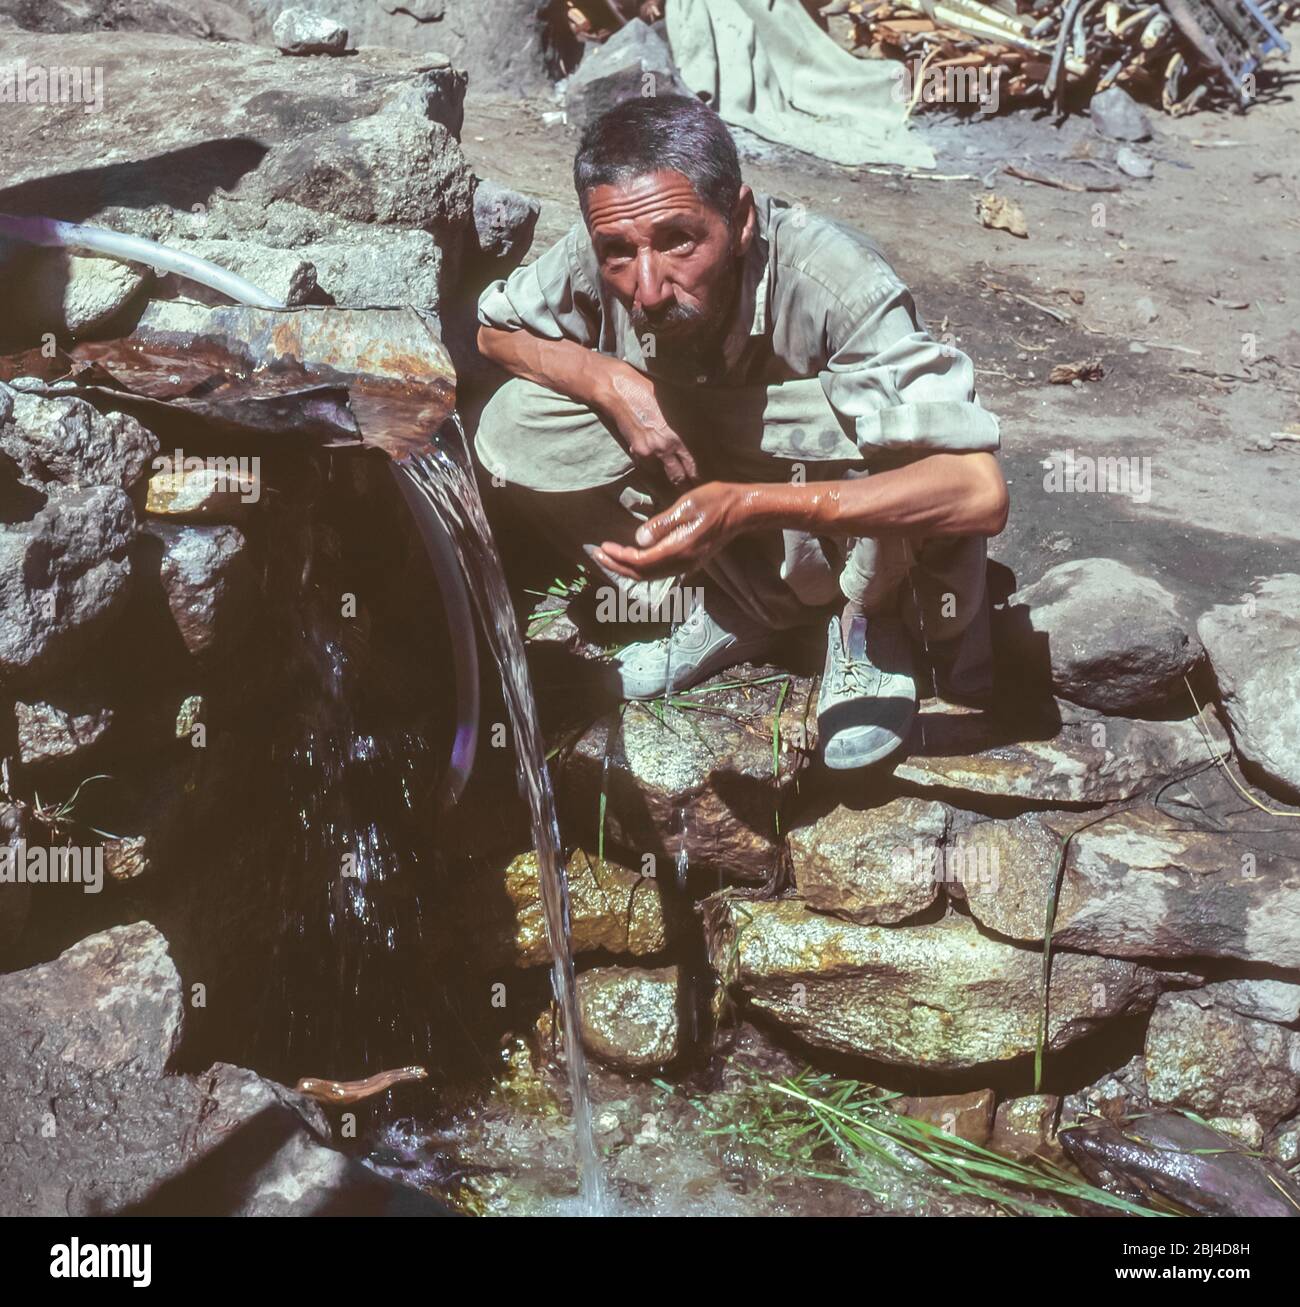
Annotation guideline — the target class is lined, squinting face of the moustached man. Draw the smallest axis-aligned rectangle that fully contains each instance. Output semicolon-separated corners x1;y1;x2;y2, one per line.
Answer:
587;171;755;363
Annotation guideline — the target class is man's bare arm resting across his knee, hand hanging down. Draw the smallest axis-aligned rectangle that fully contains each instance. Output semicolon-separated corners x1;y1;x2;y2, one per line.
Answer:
478;327;696;488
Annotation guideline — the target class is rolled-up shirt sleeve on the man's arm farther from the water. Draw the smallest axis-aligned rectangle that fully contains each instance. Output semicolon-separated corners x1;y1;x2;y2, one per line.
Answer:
821;269;1001;461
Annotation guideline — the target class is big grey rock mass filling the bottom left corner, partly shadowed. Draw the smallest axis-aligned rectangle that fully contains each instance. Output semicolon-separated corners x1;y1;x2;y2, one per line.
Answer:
0;921;444;1217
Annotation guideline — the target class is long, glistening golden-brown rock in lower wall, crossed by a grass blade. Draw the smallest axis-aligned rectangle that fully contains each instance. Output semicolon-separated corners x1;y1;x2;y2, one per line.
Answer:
709;899;1186;1070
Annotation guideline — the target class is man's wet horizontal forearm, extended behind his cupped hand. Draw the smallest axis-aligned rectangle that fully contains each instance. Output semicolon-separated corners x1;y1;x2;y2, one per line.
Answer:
734;454;1009;536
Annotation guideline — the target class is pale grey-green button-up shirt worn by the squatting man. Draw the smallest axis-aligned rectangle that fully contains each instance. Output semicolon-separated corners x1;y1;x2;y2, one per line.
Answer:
478;193;999;463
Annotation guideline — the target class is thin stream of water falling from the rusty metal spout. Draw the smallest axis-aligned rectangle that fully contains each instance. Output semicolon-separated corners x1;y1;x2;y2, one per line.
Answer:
397;417;602;1214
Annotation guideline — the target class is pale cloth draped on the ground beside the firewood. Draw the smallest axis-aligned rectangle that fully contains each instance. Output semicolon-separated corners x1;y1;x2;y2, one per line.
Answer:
664;0;934;167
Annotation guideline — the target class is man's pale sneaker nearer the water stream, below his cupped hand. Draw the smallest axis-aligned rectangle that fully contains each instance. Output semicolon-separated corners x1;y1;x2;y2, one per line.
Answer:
614;595;777;699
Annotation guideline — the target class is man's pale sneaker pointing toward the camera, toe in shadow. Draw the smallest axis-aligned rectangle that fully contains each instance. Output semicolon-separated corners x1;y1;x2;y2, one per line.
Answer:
817;617;916;771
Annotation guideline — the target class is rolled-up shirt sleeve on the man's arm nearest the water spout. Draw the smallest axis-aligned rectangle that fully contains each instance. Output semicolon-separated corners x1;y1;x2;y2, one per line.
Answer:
478;227;601;346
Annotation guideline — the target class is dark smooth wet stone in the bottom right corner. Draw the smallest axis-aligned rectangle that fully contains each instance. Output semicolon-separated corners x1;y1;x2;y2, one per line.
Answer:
1060;1112;1300;1217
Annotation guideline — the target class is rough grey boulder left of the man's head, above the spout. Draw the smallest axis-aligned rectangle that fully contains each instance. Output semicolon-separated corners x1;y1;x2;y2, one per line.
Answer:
246;114;473;240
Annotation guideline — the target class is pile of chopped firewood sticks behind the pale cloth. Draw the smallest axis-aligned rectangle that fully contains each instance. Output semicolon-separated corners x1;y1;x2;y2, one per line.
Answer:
822;0;1291;114
